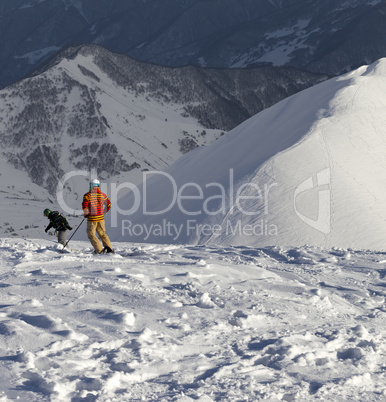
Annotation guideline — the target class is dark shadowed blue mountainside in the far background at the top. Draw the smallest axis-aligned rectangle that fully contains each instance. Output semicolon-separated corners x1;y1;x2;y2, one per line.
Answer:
0;0;386;87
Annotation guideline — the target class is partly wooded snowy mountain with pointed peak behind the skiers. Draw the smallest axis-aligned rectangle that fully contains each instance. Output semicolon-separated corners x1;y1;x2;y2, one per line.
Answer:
0;45;326;236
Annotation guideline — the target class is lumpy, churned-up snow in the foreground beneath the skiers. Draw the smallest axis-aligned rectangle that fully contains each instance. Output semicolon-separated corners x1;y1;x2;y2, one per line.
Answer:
0;239;386;402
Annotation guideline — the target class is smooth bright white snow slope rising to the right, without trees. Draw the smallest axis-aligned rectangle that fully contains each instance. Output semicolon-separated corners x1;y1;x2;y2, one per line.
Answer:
110;59;386;249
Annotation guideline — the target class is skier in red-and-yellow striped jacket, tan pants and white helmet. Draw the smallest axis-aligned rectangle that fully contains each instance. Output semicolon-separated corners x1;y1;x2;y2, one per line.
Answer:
82;179;114;254
